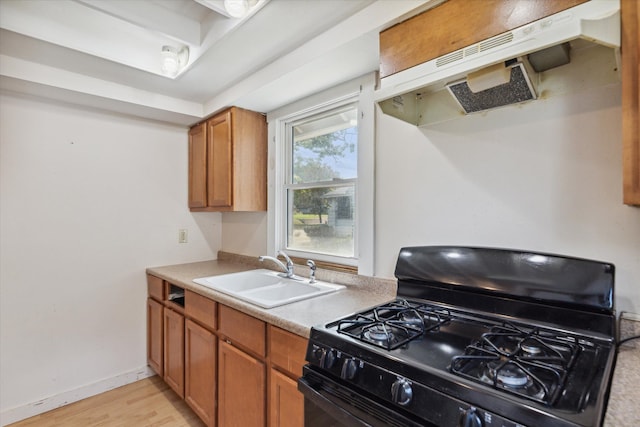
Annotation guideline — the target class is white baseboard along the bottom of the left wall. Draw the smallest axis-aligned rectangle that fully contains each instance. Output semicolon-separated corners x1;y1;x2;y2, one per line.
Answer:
0;366;155;427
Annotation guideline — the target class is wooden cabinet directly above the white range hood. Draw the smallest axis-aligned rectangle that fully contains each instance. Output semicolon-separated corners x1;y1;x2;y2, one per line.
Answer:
380;0;587;77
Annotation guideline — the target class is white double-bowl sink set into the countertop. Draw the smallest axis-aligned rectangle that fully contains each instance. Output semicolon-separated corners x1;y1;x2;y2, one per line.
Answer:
193;269;344;308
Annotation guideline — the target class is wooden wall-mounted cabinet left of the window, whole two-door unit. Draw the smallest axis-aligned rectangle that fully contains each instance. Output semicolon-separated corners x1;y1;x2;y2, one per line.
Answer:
189;107;267;212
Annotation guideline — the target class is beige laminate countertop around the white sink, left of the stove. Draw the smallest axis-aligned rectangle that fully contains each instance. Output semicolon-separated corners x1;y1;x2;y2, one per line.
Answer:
147;259;396;338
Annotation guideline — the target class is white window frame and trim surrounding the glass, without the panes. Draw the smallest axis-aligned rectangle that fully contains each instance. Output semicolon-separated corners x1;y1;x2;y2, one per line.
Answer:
267;73;375;276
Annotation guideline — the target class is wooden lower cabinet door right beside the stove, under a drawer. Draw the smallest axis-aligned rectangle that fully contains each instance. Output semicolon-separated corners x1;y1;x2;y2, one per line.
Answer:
269;369;304;427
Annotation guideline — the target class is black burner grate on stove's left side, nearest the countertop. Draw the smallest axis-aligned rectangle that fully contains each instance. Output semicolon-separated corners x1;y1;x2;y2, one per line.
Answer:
338;300;451;350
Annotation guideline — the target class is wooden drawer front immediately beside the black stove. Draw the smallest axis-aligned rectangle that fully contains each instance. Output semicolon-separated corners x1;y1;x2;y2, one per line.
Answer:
269;325;307;377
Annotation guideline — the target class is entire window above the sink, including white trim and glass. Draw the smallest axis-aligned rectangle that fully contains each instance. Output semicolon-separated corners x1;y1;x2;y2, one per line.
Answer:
267;73;376;275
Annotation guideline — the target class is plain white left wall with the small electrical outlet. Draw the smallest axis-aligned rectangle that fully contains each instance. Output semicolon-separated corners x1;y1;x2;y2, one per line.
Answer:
0;95;221;424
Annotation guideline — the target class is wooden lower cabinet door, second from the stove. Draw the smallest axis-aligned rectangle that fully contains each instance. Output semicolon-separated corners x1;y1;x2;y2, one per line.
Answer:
218;341;266;427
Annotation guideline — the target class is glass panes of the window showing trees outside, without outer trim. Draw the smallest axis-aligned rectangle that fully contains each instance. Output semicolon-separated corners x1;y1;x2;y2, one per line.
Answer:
284;103;358;258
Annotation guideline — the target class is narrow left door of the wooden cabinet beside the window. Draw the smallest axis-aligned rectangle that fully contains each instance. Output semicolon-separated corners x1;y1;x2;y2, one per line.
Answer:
189;123;207;208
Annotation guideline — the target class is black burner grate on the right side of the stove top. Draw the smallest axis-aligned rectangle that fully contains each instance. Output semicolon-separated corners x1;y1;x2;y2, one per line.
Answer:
450;324;580;405
